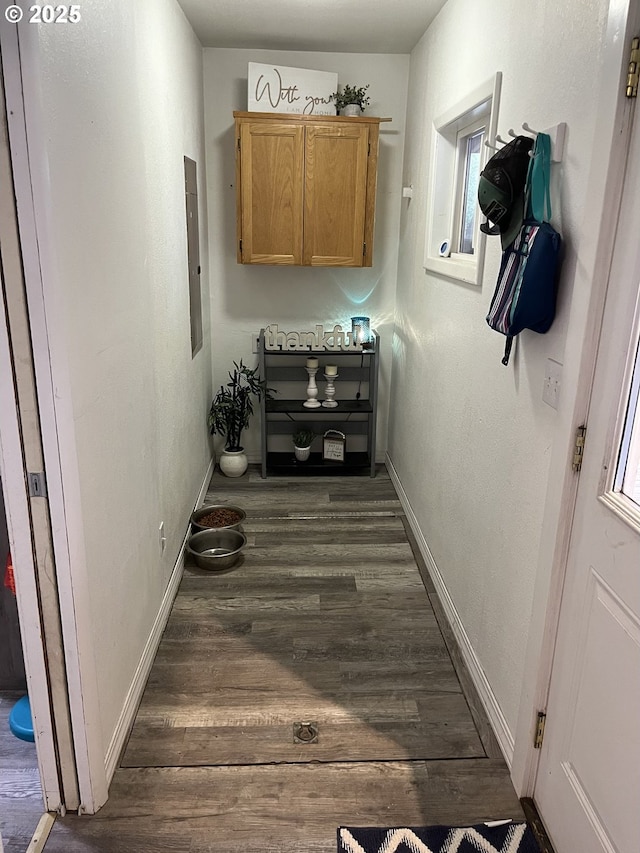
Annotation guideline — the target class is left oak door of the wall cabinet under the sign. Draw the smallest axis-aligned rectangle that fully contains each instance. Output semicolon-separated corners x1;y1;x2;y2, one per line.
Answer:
238;122;304;264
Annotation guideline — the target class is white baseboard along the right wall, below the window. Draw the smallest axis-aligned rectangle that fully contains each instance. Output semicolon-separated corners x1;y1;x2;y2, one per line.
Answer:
386;453;514;770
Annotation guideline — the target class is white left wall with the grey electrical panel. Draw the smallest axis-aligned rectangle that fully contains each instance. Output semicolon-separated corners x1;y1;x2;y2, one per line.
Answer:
27;0;212;753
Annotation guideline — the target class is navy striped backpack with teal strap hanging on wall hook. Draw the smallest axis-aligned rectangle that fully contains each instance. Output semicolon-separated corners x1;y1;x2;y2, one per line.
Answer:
487;133;562;365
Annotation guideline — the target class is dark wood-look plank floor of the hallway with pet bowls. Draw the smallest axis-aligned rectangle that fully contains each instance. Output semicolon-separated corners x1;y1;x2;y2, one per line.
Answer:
46;469;522;853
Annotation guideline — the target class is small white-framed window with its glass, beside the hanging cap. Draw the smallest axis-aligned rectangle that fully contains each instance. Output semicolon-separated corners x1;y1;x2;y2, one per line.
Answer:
424;73;502;284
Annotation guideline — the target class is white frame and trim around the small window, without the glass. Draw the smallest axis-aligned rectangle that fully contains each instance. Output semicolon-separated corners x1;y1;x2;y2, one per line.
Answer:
424;71;502;285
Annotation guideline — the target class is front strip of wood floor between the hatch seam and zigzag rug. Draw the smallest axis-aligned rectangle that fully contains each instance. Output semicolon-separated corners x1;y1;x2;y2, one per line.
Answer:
46;759;522;853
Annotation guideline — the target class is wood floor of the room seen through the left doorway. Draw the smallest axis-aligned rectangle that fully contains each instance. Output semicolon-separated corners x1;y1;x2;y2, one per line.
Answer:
0;691;44;853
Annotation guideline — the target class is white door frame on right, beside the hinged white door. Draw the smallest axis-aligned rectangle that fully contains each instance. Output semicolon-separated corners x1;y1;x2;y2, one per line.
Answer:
511;0;640;800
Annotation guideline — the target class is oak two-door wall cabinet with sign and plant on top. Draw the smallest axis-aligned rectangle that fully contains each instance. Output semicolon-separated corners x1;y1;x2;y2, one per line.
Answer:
233;112;391;267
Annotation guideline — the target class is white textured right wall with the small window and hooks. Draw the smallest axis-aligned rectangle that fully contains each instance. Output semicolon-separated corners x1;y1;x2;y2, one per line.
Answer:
389;0;607;747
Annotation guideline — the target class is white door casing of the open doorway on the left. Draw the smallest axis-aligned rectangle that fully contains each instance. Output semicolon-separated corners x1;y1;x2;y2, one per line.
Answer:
0;16;108;814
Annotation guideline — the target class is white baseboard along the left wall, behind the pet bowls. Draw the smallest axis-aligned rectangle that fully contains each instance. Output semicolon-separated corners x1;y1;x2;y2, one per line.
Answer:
104;459;215;785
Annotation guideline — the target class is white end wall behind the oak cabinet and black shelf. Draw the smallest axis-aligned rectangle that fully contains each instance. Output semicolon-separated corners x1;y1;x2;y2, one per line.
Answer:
204;48;409;459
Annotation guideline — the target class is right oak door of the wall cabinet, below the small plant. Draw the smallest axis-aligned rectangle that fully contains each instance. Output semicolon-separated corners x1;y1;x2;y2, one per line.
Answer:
304;124;369;267
